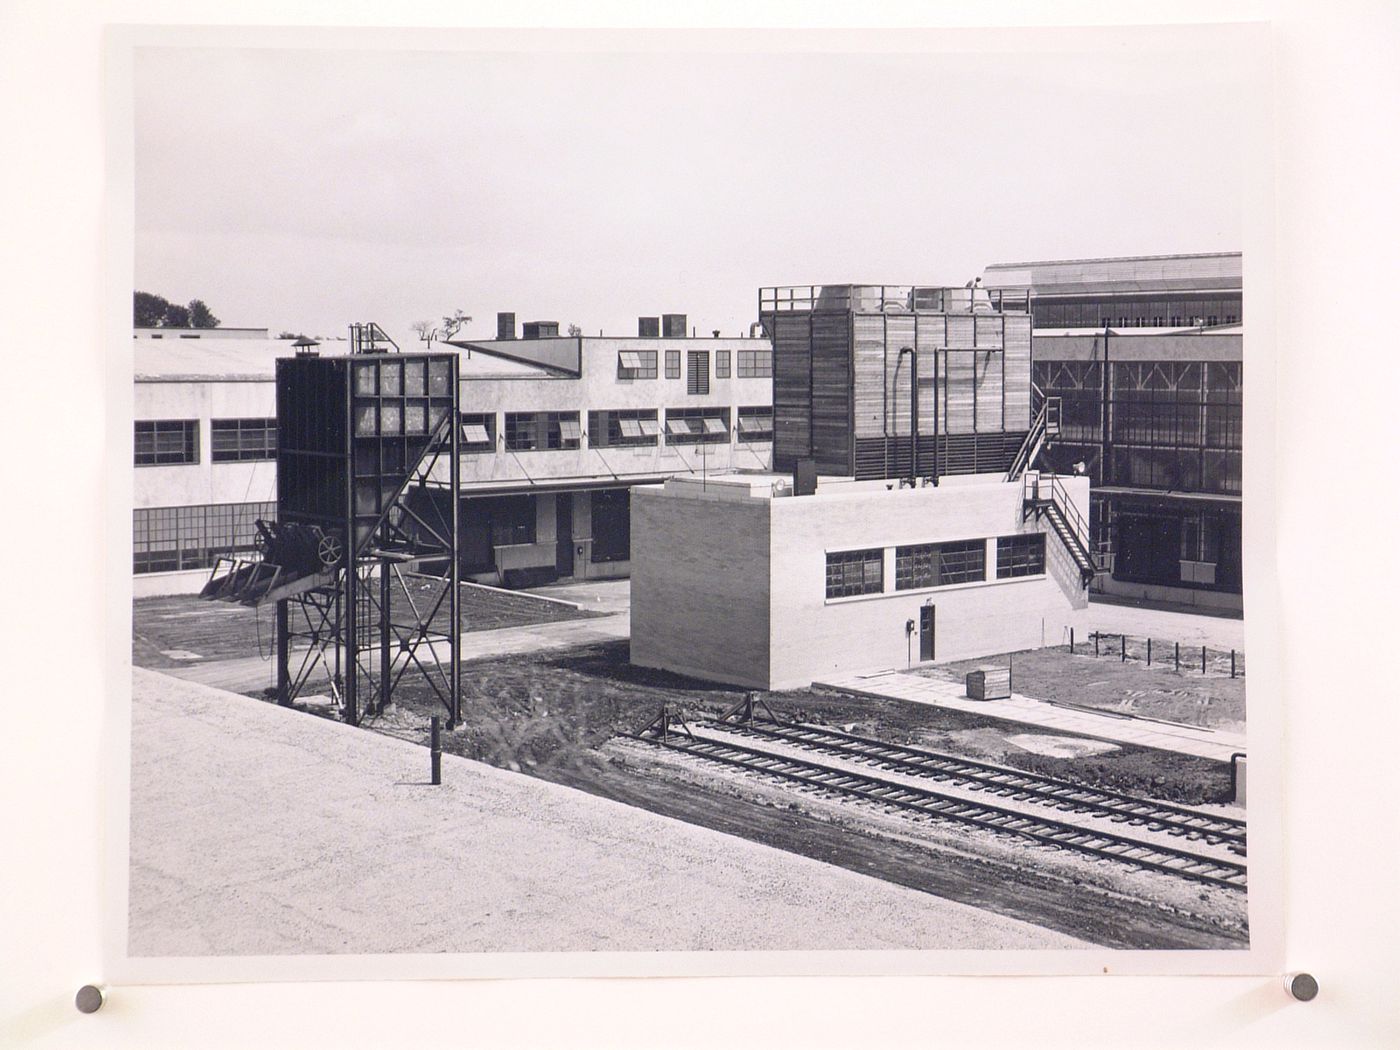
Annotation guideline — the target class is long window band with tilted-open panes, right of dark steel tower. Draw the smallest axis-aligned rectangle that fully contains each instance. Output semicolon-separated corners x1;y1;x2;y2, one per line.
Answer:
462;405;773;452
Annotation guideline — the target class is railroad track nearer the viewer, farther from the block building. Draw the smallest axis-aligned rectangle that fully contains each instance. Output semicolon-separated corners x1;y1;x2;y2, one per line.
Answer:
629;724;1247;890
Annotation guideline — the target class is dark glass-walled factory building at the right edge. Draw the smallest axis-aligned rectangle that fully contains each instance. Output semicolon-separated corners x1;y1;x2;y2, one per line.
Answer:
984;252;1243;612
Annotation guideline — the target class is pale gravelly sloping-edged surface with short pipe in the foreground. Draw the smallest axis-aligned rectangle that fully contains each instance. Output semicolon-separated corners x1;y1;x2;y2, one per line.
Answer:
129;669;1088;969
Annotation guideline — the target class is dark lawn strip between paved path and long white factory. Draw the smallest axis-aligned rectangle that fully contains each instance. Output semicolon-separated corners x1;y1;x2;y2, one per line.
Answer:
132;574;598;669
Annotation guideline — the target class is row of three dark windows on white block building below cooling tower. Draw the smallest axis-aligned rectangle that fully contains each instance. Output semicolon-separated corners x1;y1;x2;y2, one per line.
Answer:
826;532;1046;598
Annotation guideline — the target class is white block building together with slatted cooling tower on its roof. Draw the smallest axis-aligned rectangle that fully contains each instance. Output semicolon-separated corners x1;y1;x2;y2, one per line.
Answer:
631;286;1096;689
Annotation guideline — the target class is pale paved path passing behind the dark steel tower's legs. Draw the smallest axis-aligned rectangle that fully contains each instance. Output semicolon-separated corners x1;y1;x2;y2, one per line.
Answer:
164;613;630;693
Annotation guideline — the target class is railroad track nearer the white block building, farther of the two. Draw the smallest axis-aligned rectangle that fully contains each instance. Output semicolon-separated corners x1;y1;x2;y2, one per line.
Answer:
701;717;1246;854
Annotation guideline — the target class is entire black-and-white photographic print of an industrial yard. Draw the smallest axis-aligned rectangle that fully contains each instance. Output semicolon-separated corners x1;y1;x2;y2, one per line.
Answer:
112;27;1271;973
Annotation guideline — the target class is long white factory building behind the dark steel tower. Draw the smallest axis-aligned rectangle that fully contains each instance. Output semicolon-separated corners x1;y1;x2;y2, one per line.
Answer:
133;315;773;596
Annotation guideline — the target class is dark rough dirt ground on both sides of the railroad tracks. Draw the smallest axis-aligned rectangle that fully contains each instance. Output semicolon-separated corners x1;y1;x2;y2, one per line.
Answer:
252;643;1246;948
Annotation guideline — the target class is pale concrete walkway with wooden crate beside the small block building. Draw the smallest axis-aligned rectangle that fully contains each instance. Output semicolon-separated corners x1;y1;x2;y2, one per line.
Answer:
812;671;1245;762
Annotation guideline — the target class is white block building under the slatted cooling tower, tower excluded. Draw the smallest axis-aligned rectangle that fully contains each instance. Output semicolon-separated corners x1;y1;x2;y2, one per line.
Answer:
631;475;1089;689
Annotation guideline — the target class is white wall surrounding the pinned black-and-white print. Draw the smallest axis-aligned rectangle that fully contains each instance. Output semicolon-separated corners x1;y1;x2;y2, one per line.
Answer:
0;0;1400;1049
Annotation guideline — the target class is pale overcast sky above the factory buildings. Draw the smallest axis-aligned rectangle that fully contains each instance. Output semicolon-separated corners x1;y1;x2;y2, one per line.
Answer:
136;29;1246;344
